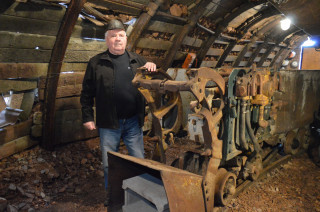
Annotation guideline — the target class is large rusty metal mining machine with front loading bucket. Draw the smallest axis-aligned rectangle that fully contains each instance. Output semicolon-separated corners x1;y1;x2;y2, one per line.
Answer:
108;67;320;212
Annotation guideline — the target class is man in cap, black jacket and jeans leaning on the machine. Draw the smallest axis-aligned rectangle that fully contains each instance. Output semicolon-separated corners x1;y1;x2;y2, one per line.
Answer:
80;20;156;205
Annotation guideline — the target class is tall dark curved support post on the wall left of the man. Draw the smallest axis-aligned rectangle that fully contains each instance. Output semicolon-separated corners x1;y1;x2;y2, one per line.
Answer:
41;0;86;149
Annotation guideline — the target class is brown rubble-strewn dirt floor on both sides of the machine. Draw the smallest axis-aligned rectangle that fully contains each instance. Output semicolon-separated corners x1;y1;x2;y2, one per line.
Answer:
0;136;320;212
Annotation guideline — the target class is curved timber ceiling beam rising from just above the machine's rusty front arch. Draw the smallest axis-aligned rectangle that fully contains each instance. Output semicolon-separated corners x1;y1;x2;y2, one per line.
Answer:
197;1;267;66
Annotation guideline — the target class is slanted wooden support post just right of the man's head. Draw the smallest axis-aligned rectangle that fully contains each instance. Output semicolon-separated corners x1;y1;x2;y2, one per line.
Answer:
127;0;165;51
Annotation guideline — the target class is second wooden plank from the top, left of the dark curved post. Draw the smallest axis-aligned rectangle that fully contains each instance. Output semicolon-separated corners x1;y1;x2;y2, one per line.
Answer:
0;15;60;36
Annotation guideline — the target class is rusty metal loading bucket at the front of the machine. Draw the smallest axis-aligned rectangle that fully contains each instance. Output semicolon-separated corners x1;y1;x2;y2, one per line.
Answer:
108;152;205;212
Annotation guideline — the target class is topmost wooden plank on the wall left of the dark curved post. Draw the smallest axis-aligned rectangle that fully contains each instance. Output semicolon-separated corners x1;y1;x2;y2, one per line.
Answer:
3;1;66;22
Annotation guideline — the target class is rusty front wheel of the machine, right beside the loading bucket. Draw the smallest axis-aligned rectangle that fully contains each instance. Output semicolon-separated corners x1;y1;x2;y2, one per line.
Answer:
215;168;237;206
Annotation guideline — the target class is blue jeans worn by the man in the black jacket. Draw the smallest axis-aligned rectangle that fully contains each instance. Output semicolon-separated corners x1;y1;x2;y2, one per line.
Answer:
99;116;144;189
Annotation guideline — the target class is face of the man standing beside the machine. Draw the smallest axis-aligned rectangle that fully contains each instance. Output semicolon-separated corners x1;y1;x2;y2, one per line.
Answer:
106;29;127;55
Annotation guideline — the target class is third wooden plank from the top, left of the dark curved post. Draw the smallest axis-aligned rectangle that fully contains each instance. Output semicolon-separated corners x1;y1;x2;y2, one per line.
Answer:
0;31;56;50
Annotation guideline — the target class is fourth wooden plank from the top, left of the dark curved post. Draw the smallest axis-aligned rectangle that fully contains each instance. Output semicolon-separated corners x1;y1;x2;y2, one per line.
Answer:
0;48;51;63
